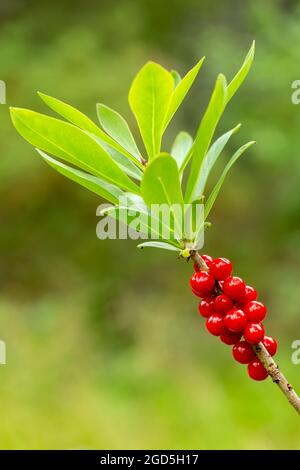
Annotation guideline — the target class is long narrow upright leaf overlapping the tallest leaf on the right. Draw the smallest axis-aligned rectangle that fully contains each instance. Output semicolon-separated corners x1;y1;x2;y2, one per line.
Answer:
184;74;226;203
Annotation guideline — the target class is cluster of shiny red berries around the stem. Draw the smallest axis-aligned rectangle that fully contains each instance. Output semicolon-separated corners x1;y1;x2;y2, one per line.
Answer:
190;255;277;380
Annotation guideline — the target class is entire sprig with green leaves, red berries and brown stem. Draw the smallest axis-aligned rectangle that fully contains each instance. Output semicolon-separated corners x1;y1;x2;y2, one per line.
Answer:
11;42;300;413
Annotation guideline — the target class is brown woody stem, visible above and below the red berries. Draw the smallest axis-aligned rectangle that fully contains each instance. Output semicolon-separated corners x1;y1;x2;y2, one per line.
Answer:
191;251;300;414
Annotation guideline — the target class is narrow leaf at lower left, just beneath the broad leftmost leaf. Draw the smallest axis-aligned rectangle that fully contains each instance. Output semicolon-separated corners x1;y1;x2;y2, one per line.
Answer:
36;149;124;204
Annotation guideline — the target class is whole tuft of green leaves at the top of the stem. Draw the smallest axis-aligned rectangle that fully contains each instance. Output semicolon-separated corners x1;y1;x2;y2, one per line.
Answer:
11;42;255;251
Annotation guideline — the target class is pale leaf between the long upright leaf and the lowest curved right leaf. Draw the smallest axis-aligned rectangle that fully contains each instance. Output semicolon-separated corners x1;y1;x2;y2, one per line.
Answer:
198;124;241;195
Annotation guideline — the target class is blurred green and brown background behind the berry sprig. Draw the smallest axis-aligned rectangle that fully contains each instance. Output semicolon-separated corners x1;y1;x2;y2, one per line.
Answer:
0;0;300;449
